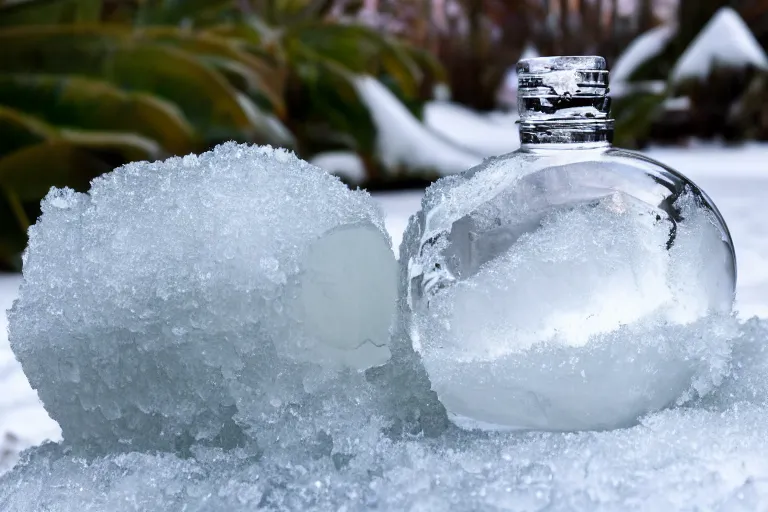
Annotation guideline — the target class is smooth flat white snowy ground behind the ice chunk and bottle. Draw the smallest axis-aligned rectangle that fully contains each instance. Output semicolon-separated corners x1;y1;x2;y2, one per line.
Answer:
0;146;768;470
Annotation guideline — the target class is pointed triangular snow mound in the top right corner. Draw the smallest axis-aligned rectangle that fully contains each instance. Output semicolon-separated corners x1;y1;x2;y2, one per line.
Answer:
672;7;768;83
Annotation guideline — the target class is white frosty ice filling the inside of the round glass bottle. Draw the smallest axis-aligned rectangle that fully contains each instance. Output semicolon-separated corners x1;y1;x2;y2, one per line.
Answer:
400;187;734;430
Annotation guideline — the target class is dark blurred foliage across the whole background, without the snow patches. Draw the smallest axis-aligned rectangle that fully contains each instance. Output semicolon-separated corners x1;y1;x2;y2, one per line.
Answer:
0;0;768;269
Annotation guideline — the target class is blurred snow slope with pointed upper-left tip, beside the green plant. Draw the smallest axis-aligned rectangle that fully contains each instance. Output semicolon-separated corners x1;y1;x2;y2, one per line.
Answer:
356;77;482;175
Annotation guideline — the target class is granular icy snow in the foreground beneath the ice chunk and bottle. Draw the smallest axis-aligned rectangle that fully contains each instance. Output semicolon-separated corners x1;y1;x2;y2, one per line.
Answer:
0;320;768;512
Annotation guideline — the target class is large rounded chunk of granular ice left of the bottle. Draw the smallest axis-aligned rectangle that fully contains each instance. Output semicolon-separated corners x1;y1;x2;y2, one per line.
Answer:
9;143;397;451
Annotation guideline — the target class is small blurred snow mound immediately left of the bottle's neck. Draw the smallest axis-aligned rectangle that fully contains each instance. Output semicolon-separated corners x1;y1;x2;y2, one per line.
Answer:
424;101;520;157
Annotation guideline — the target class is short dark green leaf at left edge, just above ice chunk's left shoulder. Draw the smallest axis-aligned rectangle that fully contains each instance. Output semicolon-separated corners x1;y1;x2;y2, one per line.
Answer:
0;141;111;202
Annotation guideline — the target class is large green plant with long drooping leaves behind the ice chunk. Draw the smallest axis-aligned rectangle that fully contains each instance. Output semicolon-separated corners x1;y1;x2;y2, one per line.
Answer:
0;0;440;268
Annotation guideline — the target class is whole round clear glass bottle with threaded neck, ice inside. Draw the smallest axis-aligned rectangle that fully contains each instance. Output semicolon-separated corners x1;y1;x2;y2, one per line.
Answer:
401;57;736;430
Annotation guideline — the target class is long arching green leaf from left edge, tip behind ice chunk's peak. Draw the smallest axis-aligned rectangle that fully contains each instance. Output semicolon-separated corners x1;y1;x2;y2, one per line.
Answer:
0;26;272;140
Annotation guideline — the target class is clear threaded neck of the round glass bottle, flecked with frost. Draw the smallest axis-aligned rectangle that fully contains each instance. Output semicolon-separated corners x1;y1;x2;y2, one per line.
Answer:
517;56;613;147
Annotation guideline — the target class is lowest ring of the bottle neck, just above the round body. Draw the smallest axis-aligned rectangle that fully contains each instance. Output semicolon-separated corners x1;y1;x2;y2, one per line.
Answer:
519;118;614;149
